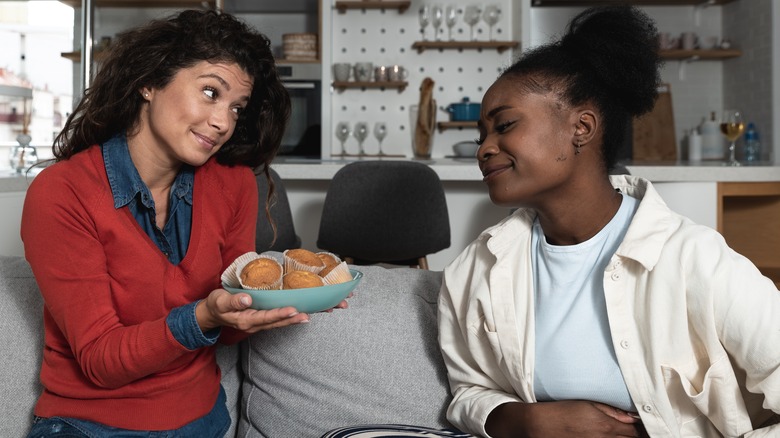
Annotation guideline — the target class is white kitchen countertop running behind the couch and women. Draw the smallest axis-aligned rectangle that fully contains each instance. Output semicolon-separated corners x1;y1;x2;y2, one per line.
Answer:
0;157;780;193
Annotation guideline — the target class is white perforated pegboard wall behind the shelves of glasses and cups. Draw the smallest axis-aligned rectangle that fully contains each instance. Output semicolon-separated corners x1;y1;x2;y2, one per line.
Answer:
323;0;515;157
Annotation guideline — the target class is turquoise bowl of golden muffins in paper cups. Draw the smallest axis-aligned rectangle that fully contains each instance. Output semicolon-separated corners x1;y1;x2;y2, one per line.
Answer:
222;248;363;313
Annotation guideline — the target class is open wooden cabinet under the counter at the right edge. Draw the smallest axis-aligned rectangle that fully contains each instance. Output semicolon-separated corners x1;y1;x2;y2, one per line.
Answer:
717;182;780;287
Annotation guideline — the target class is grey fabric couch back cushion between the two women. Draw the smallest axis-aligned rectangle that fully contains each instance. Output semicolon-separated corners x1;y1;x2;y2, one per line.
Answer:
238;266;451;438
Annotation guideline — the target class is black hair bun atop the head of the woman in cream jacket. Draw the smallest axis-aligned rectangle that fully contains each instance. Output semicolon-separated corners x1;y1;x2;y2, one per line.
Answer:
560;6;661;116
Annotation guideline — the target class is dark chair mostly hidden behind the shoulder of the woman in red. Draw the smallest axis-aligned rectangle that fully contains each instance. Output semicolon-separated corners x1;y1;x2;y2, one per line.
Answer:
255;167;301;253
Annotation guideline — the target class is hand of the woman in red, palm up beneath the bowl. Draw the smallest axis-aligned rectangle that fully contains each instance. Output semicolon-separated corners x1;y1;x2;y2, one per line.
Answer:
195;289;309;333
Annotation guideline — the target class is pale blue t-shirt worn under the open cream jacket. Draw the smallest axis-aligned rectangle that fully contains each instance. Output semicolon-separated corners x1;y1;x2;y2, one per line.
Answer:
531;195;639;411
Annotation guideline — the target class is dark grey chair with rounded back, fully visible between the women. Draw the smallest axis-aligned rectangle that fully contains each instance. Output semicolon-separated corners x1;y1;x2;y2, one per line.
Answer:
317;161;450;269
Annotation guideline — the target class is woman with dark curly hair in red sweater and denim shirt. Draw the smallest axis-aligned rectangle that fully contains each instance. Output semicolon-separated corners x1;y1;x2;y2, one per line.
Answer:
22;10;326;437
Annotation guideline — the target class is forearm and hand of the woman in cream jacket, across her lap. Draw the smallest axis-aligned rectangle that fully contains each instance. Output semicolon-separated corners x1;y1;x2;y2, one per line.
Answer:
485;400;644;438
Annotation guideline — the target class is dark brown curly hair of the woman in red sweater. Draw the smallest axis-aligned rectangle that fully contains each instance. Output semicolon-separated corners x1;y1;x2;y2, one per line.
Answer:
53;10;290;171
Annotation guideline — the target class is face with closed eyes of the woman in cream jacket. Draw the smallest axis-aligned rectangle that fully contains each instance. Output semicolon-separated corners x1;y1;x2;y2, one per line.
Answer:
477;77;579;208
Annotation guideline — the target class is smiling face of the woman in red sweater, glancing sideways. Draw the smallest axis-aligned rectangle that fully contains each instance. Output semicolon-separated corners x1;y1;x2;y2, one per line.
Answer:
133;61;252;167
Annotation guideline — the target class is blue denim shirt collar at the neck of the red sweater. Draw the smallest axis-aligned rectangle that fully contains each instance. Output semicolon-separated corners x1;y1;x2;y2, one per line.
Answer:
103;134;195;208
